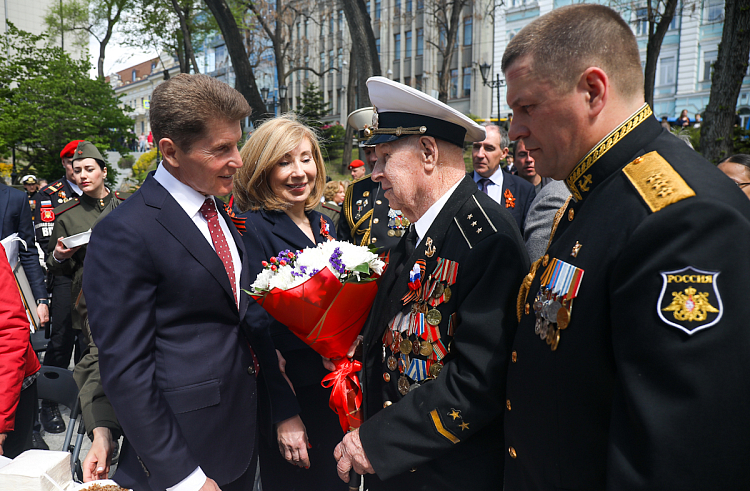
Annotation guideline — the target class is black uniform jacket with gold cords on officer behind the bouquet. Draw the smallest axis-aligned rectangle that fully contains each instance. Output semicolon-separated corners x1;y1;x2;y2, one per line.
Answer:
336;174;401;253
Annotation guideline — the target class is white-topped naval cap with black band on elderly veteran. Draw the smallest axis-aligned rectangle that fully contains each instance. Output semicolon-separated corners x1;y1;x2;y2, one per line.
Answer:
365;77;486;147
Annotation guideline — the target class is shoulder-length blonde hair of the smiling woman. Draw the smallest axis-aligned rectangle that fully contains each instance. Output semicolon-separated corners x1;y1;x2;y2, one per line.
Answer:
233;113;326;212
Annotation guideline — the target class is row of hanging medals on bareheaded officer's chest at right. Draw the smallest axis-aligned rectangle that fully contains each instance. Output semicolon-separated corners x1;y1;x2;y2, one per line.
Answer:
534;259;583;351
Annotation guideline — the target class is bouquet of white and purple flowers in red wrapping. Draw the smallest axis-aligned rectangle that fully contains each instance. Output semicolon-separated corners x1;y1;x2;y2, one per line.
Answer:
249;240;385;431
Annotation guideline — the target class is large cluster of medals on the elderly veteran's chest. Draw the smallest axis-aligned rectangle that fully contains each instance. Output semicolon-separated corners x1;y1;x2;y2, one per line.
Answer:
383;258;458;395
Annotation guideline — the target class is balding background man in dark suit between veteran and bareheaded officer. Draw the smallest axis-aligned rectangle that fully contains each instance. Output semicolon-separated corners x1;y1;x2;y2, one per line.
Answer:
471;125;536;235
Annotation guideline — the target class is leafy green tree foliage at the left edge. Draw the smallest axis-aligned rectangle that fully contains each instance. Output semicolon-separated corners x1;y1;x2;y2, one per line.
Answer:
0;22;133;184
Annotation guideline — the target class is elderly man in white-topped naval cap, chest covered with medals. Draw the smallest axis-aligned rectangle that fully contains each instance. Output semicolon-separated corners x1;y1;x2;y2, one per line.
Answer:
334;77;529;491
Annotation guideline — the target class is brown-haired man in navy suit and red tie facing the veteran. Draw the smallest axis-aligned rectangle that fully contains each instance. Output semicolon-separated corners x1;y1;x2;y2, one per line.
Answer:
83;74;268;491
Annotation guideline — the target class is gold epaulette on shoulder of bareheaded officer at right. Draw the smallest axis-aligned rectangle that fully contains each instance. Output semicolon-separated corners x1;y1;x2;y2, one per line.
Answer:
622;151;695;213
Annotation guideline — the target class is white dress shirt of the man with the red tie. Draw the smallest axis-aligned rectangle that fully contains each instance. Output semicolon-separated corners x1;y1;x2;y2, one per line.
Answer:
154;164;242;491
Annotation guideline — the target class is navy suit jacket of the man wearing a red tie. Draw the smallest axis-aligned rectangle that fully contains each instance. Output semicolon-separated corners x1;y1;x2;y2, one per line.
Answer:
83;175;262;491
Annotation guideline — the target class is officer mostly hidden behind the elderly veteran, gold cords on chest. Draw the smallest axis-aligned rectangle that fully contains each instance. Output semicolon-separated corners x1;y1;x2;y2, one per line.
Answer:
337;107;410;253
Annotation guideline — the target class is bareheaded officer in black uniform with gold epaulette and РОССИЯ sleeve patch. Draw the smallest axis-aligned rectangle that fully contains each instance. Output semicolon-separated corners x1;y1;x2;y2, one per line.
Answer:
502;4;750;491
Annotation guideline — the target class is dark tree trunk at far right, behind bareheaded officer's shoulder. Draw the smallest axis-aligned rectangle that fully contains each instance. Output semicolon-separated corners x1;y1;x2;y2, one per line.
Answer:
700;0;750;162
